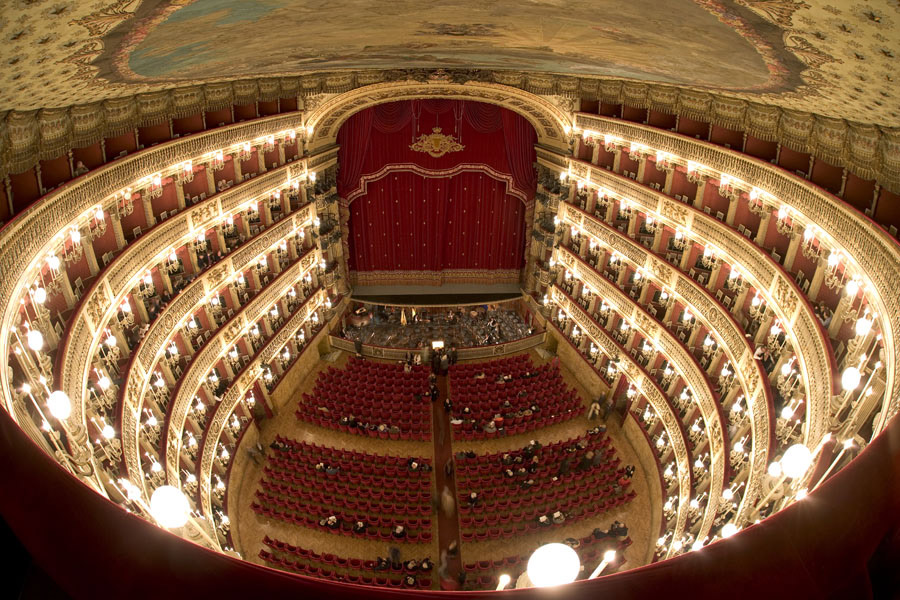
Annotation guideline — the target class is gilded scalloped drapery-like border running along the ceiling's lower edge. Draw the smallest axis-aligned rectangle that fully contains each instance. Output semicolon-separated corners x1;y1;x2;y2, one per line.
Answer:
0;69;900;193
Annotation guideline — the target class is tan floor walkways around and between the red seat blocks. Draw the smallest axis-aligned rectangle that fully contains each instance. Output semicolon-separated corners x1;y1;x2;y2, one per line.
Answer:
228;351;658;586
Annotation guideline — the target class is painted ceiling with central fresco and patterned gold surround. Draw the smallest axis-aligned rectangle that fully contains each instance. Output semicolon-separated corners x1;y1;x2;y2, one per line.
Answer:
0;0;900;126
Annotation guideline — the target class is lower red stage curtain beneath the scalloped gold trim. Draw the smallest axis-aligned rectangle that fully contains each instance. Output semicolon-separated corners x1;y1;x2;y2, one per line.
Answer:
348;172;525;271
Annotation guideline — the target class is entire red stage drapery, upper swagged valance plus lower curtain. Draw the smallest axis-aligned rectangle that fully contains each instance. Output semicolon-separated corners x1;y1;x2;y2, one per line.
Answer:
338;99;537;278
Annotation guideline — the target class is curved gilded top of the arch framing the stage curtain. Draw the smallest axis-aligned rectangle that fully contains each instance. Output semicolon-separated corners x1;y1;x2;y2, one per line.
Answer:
306;80;572;153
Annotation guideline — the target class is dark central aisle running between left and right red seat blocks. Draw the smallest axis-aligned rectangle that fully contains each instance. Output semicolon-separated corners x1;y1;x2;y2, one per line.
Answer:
431;375;462;586
